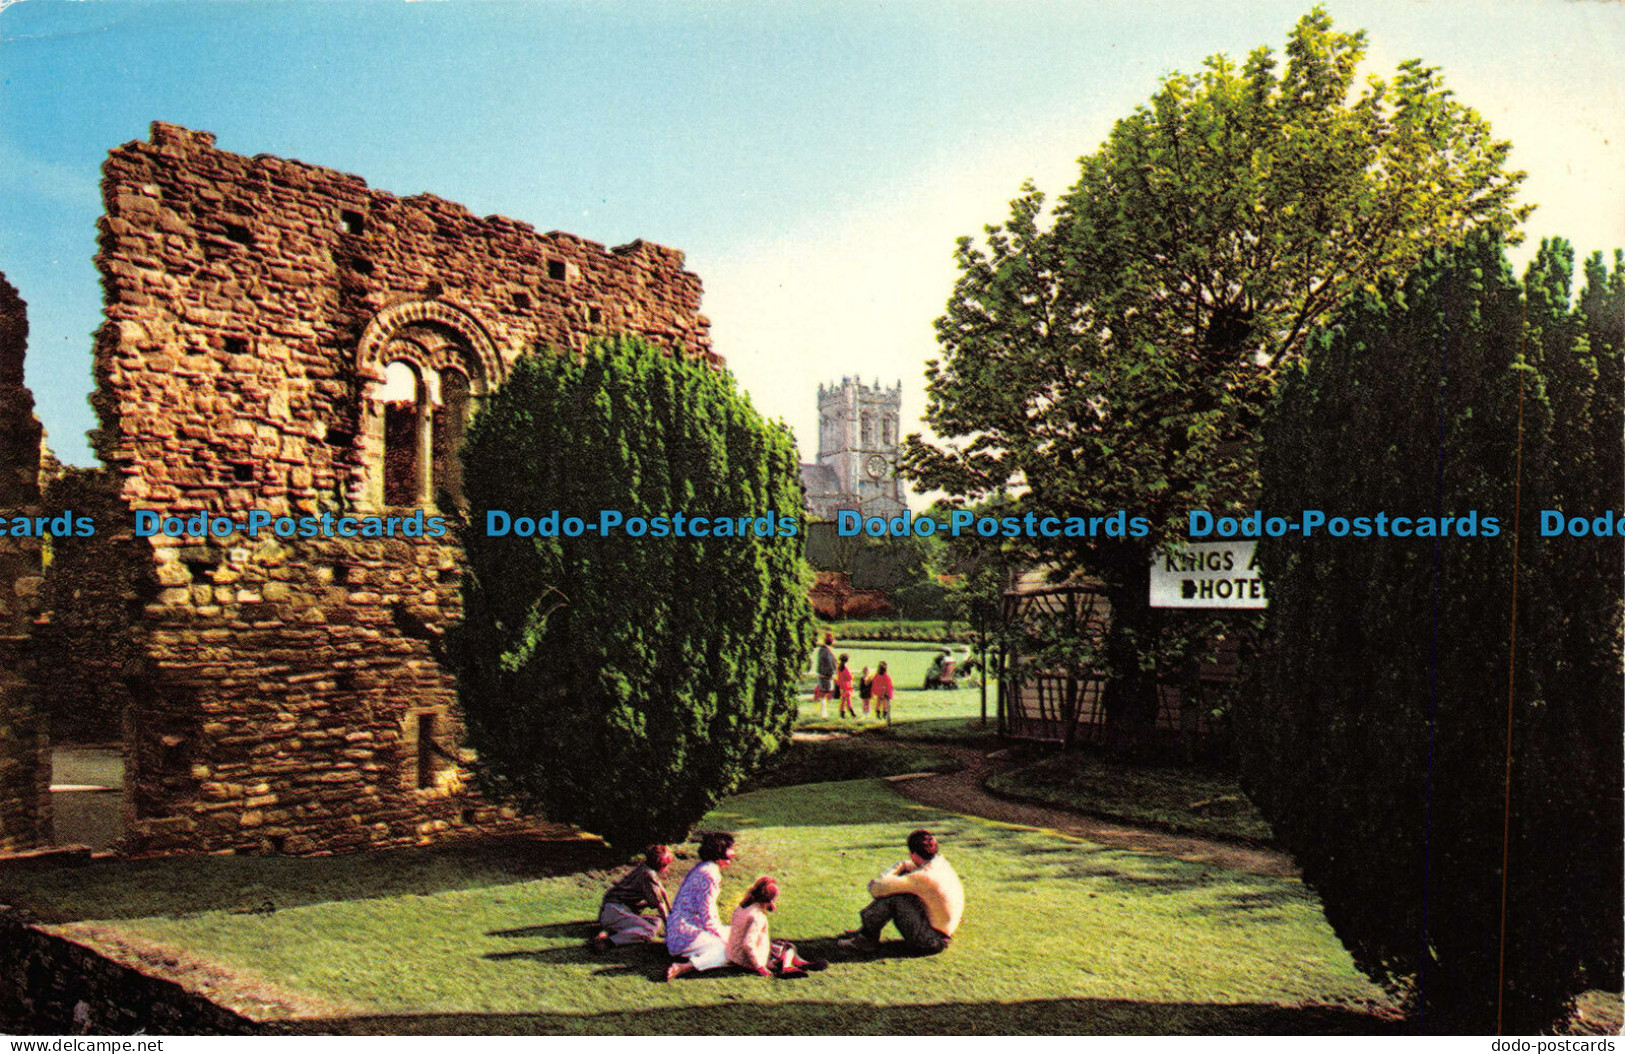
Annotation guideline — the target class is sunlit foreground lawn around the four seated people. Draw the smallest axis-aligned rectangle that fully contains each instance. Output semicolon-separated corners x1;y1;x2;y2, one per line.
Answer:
0;781;1388;1033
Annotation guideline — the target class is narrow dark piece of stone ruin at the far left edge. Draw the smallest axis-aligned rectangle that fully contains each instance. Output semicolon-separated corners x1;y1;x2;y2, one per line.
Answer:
0;276;50;849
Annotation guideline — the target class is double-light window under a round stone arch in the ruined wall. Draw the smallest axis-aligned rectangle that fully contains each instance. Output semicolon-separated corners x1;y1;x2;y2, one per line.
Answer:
359;300;502;507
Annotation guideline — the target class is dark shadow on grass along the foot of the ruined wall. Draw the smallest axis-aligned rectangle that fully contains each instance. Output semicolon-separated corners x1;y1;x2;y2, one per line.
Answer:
0;836;627;922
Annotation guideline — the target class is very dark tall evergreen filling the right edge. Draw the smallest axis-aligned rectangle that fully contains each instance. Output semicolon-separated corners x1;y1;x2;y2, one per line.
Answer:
1238;235;1625;1033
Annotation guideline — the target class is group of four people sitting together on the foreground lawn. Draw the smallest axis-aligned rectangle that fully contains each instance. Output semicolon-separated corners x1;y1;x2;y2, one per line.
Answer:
592;830;965;981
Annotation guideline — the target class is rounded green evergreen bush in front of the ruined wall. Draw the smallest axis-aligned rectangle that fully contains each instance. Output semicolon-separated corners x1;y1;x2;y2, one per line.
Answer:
452;339;813;844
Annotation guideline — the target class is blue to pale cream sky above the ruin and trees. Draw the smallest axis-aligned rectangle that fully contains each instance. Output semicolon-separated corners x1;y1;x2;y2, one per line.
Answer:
0;0;1625;463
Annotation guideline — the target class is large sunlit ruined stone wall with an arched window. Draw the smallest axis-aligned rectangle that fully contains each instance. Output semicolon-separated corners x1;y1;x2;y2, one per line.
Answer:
86;123;710;853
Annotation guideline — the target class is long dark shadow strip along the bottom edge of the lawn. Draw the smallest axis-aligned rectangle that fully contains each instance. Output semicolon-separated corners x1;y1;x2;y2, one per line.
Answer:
278;979;1414;1036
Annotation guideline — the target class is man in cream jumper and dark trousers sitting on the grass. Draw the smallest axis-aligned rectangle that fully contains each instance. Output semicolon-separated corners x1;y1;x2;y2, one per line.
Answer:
835;830;965;955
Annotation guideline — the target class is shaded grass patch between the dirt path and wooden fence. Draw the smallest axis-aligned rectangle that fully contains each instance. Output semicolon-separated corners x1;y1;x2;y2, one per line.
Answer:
988;750;1274;841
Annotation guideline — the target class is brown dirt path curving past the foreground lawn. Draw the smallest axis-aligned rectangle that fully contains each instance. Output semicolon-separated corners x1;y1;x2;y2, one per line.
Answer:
871;744;1298;877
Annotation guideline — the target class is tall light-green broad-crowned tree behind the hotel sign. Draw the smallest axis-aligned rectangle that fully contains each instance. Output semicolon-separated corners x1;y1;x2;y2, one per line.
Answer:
904;8;1526;723
